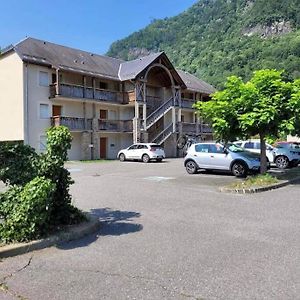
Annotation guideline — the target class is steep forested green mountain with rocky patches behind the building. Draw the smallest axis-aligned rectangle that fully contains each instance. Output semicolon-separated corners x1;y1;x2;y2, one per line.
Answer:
107;0;300;88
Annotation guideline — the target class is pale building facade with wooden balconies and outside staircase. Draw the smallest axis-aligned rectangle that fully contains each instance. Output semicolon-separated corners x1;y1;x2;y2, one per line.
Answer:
0;41;213;160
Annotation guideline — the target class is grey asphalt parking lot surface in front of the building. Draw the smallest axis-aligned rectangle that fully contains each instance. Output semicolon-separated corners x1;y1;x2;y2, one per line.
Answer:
0;159;300;300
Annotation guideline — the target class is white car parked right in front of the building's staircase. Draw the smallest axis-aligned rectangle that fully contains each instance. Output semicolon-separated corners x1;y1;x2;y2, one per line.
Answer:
117;143;166;163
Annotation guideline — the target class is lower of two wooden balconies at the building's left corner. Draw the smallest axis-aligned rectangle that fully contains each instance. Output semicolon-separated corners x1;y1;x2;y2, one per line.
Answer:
51;116;92;131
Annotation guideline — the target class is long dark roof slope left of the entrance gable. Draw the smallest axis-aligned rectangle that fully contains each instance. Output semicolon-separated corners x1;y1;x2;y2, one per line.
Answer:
14;38;123;80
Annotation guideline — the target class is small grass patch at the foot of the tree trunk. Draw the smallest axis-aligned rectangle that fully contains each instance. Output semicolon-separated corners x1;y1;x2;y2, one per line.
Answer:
228;174;279;189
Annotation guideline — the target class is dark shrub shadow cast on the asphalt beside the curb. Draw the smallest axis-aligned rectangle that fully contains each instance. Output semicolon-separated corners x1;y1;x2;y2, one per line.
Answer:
57;208;143;250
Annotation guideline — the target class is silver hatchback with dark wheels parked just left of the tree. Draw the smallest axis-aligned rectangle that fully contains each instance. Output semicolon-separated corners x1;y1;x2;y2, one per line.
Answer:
184;142;260;177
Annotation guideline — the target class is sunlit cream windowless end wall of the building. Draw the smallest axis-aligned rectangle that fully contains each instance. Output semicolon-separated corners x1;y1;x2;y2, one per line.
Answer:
0;53;24;141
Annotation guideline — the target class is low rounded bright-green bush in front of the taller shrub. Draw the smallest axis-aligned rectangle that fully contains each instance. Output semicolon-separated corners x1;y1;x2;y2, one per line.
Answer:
0;177;55;242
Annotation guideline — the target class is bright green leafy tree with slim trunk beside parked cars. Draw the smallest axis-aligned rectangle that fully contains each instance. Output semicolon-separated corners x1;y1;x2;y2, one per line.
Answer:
195;69;300;173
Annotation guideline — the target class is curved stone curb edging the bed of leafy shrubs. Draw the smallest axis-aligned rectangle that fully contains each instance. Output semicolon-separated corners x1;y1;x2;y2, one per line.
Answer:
0;215;100;258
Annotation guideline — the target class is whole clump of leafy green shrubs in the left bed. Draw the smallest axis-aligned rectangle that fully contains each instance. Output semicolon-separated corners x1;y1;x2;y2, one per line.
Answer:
0;126;86;242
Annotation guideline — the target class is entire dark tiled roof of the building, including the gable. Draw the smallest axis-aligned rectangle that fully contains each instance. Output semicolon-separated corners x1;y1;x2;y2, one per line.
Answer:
2;38;216;94
